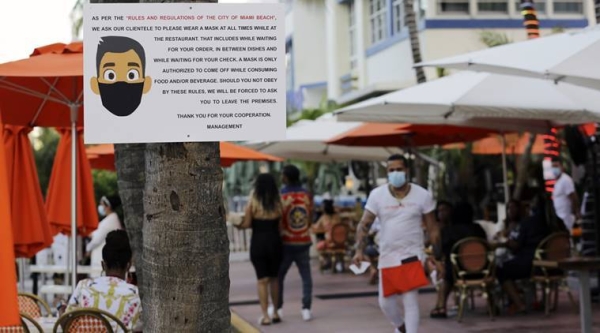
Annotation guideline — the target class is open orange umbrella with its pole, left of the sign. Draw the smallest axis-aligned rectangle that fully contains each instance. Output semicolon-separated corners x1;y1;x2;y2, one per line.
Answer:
0;42;92;289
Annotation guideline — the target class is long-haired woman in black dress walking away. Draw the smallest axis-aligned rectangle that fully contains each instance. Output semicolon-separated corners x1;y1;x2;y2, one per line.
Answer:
238;173;283;326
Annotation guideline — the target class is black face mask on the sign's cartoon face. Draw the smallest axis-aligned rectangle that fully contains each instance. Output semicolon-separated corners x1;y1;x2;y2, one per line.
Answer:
98;82;144;117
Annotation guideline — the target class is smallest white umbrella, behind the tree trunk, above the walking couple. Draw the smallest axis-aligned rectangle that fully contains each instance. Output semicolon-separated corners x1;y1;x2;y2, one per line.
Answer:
249;117;402;162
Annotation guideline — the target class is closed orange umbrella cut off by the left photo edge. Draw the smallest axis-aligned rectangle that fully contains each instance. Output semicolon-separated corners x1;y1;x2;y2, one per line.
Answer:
0;117;21;327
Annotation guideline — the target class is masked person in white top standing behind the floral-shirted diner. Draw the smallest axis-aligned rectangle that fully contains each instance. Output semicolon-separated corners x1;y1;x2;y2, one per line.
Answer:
85;196;123;277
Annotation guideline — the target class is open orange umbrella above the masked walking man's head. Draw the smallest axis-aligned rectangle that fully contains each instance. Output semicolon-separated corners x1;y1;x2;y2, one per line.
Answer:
327;123;493;147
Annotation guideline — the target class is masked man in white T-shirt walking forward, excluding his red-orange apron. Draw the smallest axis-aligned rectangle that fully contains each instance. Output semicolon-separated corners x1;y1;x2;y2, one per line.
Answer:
354;155;440;333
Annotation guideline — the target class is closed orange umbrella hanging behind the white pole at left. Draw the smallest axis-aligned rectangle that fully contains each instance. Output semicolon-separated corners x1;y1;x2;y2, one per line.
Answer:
46;128;98;236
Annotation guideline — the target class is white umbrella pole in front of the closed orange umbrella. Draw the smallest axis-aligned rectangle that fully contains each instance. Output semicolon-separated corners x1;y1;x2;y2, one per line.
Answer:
69;105;78;292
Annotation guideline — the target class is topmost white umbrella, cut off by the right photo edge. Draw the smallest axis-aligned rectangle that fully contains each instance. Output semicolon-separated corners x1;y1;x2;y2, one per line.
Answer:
416;26;600;90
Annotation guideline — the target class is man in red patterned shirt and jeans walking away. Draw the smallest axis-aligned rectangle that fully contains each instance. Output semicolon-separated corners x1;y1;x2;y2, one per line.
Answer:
271;164;312;321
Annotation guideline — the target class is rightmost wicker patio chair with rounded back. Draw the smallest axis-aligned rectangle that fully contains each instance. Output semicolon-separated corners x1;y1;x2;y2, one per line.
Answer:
531;232;578;315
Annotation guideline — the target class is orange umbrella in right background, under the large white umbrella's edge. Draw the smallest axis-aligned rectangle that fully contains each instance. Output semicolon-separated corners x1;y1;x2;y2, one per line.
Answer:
444;133;544;155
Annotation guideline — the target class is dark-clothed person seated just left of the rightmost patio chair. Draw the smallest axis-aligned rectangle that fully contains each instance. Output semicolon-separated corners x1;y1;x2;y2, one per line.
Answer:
496;194;550;313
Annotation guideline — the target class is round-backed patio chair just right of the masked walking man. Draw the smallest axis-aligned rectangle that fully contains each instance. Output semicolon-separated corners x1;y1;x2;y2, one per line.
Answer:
450;237;496;322
